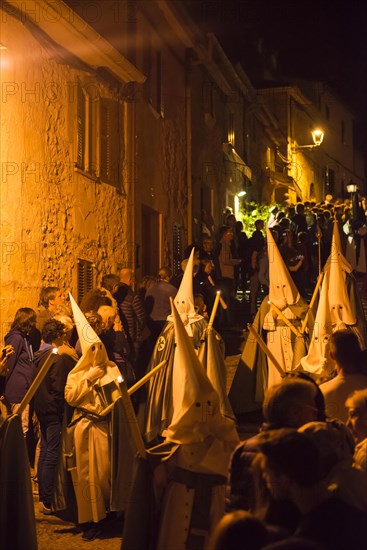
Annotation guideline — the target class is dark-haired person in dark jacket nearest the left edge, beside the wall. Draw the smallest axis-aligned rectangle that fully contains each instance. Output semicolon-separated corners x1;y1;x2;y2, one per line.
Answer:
4;307;37;437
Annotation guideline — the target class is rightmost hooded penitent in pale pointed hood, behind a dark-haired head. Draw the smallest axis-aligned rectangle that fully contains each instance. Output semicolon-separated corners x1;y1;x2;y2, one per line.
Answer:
301;223;366;375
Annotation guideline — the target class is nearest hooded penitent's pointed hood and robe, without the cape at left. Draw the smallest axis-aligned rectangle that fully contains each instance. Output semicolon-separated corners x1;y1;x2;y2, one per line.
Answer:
152;300;239;550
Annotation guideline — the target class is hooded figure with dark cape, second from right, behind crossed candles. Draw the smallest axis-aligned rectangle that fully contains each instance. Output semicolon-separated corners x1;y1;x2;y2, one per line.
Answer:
228;228;312;415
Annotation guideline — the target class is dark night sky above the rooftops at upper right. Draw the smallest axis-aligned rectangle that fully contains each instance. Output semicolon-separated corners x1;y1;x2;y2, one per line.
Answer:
183;0;367;144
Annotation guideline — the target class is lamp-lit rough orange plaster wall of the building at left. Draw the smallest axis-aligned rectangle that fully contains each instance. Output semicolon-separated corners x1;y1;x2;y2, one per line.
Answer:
0;11;126;336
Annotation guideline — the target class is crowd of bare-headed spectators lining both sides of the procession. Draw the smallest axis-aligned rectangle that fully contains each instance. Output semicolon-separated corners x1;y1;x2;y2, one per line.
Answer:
1;193;367;550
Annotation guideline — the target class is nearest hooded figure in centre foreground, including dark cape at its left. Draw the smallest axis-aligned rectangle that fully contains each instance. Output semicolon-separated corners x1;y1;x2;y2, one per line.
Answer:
122;305;239;550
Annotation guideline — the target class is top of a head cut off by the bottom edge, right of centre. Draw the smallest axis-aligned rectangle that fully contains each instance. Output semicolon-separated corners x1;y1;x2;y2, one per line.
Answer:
207;510;269;550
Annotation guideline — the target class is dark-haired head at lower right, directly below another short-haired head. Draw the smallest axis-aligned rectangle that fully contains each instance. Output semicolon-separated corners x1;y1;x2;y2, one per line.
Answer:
260;430;325;501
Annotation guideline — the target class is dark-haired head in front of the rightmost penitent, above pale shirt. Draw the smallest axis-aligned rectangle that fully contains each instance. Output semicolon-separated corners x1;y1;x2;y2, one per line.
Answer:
330;329;362;373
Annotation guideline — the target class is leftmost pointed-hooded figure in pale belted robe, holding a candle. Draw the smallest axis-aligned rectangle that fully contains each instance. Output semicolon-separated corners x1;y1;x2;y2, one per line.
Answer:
65;295;135;535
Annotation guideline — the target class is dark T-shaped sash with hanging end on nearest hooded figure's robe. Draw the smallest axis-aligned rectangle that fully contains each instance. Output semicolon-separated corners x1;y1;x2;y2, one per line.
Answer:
170;467;227;550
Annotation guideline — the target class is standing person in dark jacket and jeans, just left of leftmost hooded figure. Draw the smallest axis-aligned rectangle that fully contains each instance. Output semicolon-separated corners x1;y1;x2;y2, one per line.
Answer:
34;319;76;514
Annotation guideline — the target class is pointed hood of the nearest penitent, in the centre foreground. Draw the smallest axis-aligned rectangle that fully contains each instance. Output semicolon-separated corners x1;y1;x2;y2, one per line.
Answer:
163;300;238;444
